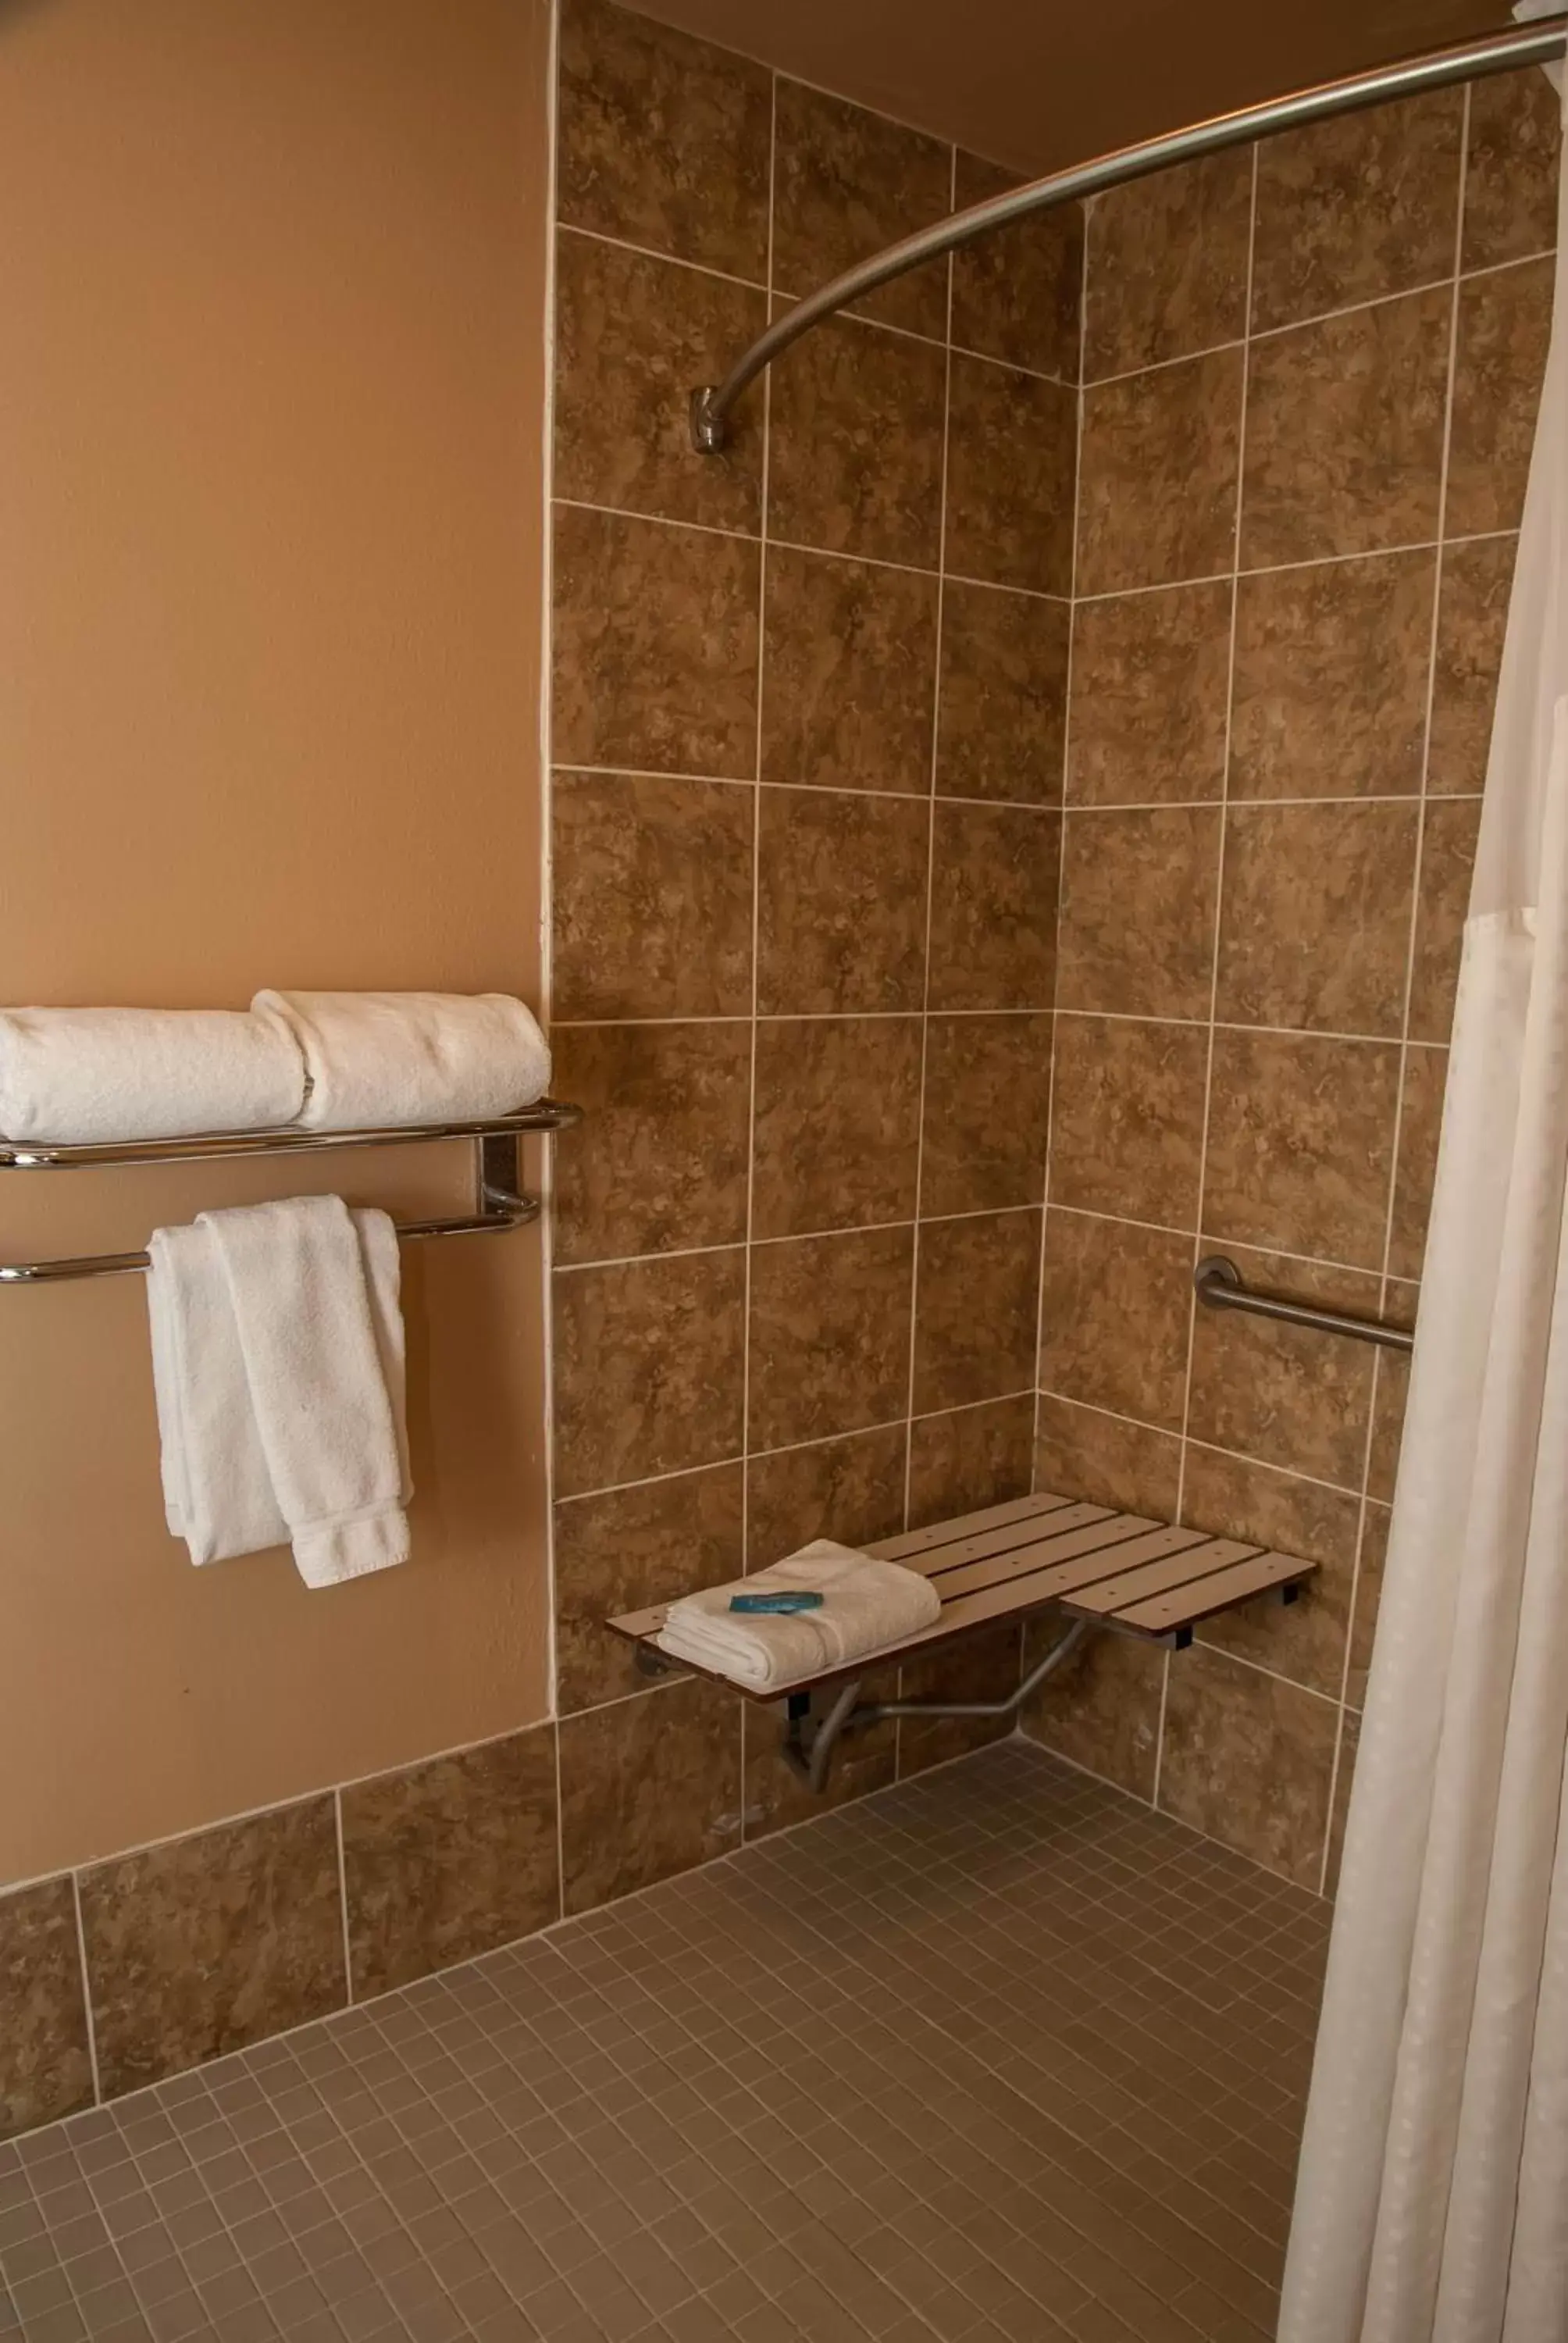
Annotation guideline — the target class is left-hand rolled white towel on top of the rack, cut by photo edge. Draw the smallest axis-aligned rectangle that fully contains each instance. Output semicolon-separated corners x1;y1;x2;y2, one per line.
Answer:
0;1010;305;1146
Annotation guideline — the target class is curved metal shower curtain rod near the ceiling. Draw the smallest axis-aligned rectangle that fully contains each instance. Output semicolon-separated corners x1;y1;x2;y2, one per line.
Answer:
691;16;1568;455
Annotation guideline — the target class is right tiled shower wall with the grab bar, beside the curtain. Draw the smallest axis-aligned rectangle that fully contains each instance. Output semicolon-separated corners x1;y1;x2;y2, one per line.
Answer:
1029;70;1559;1886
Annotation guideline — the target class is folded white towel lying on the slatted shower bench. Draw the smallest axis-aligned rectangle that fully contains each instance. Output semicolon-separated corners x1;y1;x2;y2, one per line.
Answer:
656;1537;943;1692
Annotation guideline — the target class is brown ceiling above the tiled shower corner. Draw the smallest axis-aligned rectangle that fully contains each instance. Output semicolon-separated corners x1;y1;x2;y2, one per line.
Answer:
633;0;1512;173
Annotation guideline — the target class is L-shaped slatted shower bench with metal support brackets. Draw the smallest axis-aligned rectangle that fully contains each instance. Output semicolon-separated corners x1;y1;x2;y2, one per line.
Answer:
607;1495;1317;1790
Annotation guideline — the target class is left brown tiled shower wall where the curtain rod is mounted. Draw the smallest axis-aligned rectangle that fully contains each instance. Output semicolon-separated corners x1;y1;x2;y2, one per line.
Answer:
553;0;1083;1846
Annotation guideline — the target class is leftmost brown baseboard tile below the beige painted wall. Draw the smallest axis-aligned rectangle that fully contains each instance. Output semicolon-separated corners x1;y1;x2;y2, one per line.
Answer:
0;1877;91;2139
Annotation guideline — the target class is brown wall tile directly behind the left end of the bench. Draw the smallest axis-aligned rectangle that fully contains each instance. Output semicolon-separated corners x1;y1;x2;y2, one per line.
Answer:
555;1464;745;1715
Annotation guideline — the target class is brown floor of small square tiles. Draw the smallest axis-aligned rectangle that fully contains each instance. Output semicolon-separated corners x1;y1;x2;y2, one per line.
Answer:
0;1741;1329;2343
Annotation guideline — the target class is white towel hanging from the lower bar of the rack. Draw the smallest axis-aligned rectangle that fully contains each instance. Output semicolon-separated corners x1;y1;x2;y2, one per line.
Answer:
148;1195;412;1586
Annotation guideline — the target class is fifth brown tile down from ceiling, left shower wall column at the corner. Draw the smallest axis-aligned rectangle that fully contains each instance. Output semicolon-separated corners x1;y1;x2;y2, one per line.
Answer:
921;1015;1050;1218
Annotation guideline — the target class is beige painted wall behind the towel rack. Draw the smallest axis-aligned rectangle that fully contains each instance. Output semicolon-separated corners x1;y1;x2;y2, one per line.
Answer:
0;0;560;1881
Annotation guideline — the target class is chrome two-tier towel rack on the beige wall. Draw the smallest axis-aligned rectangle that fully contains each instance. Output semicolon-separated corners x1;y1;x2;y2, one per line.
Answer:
0;1099;583;1286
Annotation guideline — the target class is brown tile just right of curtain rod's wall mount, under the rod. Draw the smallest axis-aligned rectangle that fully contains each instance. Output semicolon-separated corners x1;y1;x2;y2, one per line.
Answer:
768;316;947;569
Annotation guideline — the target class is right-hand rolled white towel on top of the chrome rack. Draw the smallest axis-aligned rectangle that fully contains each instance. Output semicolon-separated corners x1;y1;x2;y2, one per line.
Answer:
251;993;551;1132
